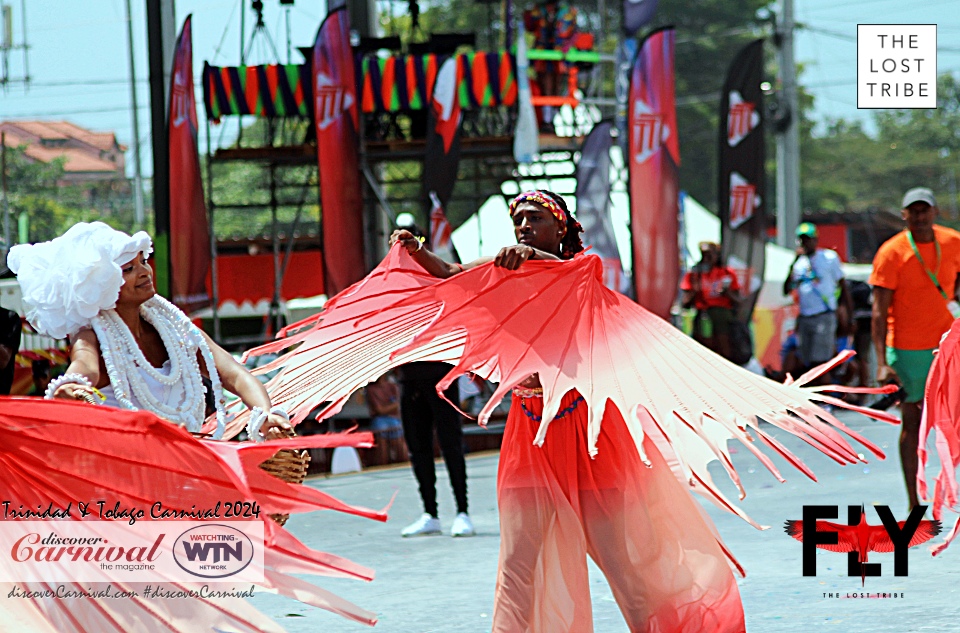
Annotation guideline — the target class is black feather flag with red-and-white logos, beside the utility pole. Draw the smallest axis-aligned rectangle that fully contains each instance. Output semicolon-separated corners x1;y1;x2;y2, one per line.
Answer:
718;40;766;321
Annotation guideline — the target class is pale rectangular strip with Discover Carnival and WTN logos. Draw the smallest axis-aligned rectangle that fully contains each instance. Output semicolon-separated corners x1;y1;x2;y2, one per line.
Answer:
0;520;266;580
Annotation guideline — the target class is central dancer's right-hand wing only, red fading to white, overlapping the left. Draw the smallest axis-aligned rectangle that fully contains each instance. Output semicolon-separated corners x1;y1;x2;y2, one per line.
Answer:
388;255;890;525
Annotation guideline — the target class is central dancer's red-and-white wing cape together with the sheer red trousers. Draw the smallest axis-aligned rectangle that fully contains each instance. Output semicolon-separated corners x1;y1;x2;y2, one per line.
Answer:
244;245;896;632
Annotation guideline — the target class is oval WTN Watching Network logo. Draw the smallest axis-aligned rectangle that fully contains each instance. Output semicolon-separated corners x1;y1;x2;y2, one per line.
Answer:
173;524;254;578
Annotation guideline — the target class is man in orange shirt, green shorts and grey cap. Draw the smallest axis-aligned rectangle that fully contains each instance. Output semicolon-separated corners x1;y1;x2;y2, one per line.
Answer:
870;187;960;509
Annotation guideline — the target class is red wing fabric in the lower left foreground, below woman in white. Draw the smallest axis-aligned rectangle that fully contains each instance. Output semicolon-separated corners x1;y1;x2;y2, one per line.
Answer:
0;398;386;633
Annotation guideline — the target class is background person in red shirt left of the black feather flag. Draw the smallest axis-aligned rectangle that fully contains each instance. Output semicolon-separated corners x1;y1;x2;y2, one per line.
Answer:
680;242;740;360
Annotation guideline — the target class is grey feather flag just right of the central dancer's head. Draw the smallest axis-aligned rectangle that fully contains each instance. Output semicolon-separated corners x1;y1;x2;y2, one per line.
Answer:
576;119;626;292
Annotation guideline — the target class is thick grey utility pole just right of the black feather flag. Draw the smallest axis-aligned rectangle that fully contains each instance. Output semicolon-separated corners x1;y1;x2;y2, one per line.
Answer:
777;0;801;250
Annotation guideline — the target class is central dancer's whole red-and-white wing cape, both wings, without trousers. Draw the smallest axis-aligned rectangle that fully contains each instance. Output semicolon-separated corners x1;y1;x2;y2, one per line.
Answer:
255;245;895;527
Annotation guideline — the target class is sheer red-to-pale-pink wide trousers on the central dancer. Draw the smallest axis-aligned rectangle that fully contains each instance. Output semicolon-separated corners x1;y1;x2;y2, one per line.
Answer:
493;391;745;633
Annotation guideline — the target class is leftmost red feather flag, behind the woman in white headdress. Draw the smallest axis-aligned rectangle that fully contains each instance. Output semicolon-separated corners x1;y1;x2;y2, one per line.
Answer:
167;16;210;314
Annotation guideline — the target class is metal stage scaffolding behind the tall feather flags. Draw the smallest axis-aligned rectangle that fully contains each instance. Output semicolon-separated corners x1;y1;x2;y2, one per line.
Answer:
204;21;622;347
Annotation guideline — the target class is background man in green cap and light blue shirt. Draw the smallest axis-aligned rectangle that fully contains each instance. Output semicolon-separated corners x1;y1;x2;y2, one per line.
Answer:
783;222;853;383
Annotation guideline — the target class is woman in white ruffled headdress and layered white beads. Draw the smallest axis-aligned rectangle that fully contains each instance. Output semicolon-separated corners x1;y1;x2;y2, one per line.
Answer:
8;222;290;441
